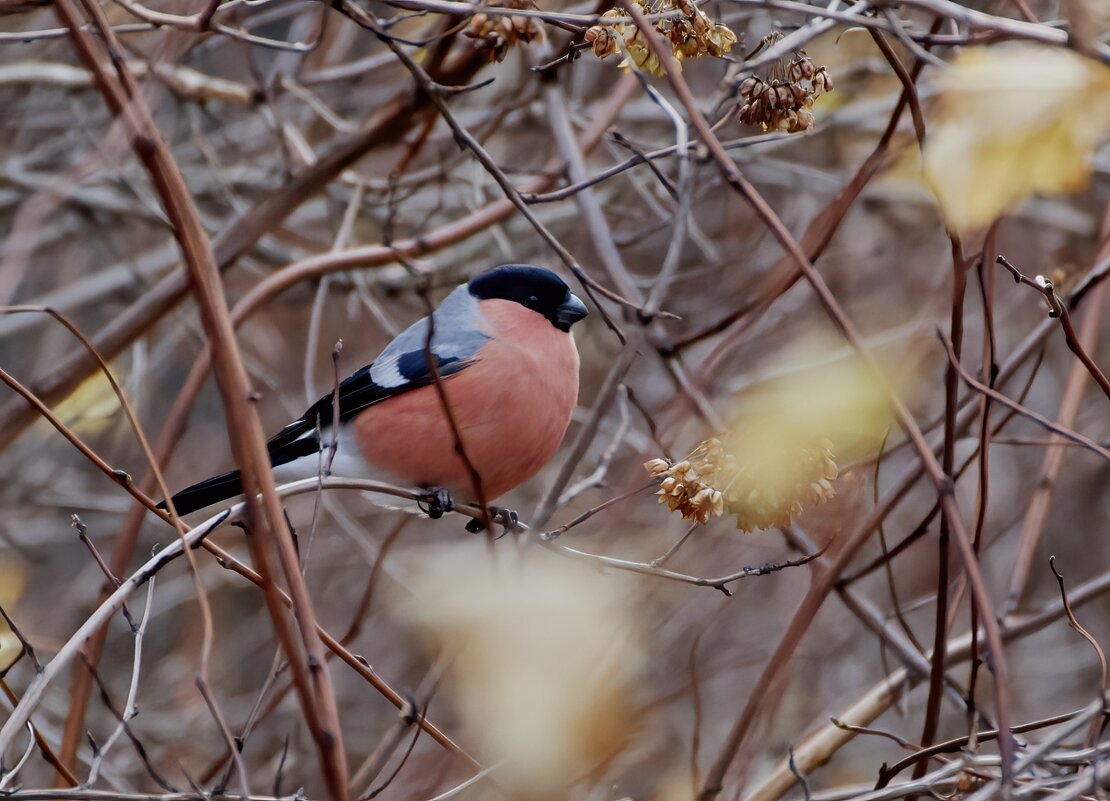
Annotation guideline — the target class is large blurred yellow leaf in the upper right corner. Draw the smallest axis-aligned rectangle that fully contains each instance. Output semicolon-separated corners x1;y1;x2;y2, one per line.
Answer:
925;43;1110;231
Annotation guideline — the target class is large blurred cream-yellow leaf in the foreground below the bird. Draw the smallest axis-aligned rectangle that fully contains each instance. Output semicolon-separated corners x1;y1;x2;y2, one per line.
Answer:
402;543;644;798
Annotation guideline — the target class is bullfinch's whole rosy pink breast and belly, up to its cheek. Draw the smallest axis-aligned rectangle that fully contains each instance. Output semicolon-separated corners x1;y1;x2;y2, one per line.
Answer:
354;300;578;500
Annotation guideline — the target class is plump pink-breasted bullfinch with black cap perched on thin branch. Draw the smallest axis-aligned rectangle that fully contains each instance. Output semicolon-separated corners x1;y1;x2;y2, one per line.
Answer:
159;264;588;523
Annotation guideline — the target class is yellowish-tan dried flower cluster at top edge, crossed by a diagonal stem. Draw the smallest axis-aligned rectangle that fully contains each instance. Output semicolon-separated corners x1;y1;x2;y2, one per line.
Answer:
585;0;736;77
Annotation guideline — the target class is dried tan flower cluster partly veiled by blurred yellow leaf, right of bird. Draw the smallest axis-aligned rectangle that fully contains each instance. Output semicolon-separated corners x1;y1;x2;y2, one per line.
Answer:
644;437;839;531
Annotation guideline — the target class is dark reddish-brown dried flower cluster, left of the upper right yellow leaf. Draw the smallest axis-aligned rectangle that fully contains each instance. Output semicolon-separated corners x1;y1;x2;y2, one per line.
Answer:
740;50;833;133
